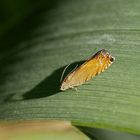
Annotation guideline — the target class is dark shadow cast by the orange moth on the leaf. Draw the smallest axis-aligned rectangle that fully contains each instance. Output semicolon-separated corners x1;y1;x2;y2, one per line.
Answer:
23;61;84;100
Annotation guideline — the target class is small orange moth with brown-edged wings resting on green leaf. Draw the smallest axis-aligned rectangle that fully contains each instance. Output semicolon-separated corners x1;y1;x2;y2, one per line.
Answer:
60;49;115;91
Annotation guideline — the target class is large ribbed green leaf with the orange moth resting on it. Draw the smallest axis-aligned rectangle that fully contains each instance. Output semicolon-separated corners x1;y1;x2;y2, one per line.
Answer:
0;0;140;134
